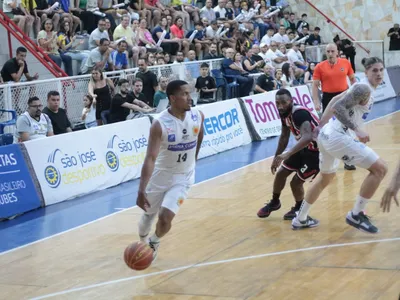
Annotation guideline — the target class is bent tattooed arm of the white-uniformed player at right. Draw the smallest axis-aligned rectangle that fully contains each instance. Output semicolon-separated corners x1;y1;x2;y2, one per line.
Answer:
332;84;371;130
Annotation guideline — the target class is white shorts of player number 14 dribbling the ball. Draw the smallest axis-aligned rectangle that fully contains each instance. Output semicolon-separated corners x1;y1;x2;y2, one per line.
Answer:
146;170;195;214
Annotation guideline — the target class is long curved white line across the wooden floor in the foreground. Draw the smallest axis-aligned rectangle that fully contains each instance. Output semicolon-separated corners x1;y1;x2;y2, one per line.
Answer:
30;237;400;300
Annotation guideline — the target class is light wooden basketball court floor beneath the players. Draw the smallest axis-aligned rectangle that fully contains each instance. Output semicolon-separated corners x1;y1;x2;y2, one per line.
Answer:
0;112;400;300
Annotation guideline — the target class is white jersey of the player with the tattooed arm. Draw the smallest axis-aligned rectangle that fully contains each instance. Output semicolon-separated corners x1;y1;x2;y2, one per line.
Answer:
329;78;375;135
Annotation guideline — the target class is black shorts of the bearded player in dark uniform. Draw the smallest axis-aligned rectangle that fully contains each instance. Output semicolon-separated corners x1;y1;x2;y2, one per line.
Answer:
282;149;319;181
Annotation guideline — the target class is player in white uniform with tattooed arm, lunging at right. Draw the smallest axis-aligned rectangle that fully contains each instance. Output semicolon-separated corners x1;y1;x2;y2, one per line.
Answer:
292;57;387;233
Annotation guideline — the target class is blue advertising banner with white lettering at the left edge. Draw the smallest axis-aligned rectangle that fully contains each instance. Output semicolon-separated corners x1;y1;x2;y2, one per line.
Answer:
0;144;40;219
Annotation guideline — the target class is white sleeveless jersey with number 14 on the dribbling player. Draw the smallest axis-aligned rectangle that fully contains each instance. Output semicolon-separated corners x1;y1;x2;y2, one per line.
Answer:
155;108;201;173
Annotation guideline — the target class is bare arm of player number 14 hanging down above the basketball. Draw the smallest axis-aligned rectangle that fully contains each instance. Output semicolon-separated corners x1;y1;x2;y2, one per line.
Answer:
136;120;162;211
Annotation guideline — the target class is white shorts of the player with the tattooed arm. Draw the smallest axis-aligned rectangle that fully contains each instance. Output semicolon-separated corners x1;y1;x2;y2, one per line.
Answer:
317;124;379;174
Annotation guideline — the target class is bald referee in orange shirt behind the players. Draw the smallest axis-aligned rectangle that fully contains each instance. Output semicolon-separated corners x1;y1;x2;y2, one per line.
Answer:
312;44;356;170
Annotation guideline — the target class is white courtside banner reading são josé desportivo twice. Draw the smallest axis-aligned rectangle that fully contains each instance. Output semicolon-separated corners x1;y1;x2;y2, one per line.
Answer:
25;118;150;205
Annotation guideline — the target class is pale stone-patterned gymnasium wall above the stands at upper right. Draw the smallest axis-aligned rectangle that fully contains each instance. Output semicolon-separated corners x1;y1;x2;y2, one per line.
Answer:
289;0;400;67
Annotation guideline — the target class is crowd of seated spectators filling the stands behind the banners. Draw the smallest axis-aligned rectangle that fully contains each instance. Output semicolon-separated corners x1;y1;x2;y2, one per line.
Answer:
1;0;362;140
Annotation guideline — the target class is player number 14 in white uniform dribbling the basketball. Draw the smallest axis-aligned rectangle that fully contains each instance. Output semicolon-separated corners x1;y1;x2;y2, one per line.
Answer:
136;80;204;259
